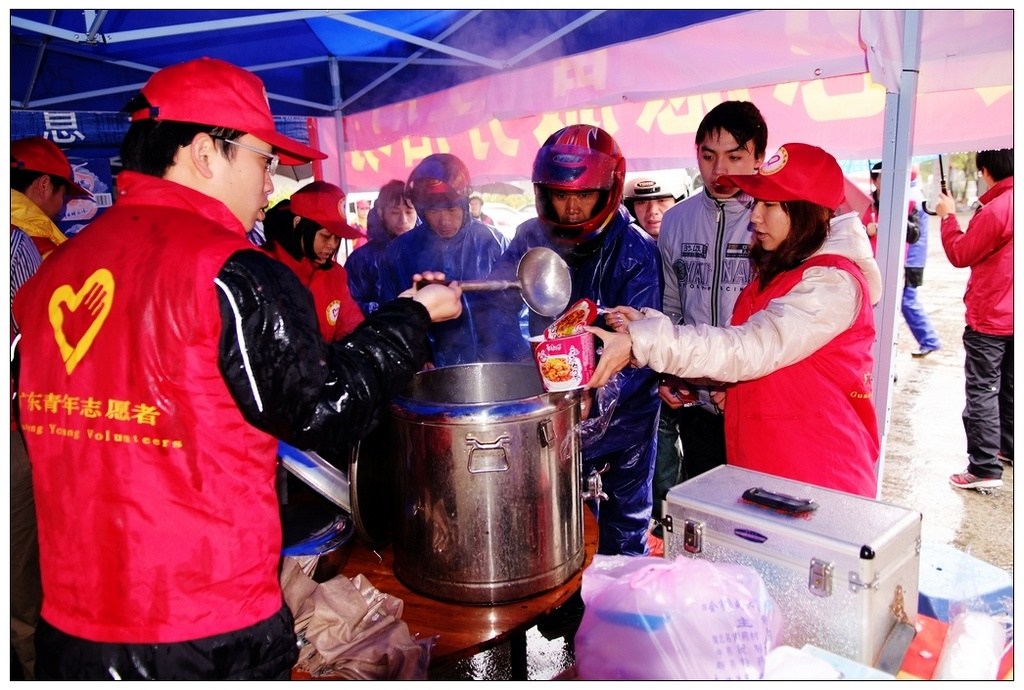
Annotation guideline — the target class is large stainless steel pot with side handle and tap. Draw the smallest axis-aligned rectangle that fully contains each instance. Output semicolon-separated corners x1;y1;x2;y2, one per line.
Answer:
391;363;584;604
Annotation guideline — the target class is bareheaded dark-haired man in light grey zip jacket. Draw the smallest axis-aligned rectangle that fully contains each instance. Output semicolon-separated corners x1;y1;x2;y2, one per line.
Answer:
654;100;768;505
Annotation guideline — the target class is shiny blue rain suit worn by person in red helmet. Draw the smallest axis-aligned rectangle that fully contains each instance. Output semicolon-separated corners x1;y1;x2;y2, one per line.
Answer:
490;206;662;556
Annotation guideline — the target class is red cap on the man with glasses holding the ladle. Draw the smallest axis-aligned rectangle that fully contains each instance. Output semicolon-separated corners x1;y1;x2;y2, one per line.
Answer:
131;57;327;165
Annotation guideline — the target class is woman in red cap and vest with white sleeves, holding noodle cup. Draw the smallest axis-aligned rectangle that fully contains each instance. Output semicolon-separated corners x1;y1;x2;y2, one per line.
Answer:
589;143;879;499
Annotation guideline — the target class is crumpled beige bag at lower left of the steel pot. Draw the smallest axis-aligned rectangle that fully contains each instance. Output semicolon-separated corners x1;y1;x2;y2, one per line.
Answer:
281;557;436;680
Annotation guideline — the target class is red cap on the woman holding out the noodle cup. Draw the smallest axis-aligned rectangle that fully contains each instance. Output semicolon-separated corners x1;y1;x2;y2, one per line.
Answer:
718;143;846;211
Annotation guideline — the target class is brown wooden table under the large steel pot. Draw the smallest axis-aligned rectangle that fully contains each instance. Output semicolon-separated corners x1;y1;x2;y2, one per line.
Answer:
342;507;597;680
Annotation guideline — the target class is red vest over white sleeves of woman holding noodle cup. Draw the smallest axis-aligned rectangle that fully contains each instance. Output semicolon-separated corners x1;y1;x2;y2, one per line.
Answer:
725;255;879;499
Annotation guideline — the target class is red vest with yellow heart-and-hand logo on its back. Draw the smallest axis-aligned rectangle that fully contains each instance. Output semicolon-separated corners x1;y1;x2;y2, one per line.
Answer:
14;172;282;643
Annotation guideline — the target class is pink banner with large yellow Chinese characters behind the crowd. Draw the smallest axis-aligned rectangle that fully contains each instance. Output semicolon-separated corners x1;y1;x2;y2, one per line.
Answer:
318;74;1013;192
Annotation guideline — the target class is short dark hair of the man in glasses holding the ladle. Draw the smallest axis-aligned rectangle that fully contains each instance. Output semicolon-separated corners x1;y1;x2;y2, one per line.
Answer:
121;94;245;177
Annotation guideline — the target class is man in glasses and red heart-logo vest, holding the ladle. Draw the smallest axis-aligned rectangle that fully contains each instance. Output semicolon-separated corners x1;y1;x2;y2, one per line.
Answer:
13;58;461;680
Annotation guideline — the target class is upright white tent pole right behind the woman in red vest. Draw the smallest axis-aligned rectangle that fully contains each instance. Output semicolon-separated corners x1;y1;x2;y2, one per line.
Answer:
873;10;923;498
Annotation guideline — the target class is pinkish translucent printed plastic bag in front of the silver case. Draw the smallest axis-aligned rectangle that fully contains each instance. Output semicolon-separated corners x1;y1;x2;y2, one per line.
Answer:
575;555;782;680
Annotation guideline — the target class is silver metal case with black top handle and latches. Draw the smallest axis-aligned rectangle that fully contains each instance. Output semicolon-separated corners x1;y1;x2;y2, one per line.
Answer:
665;466;922;665
